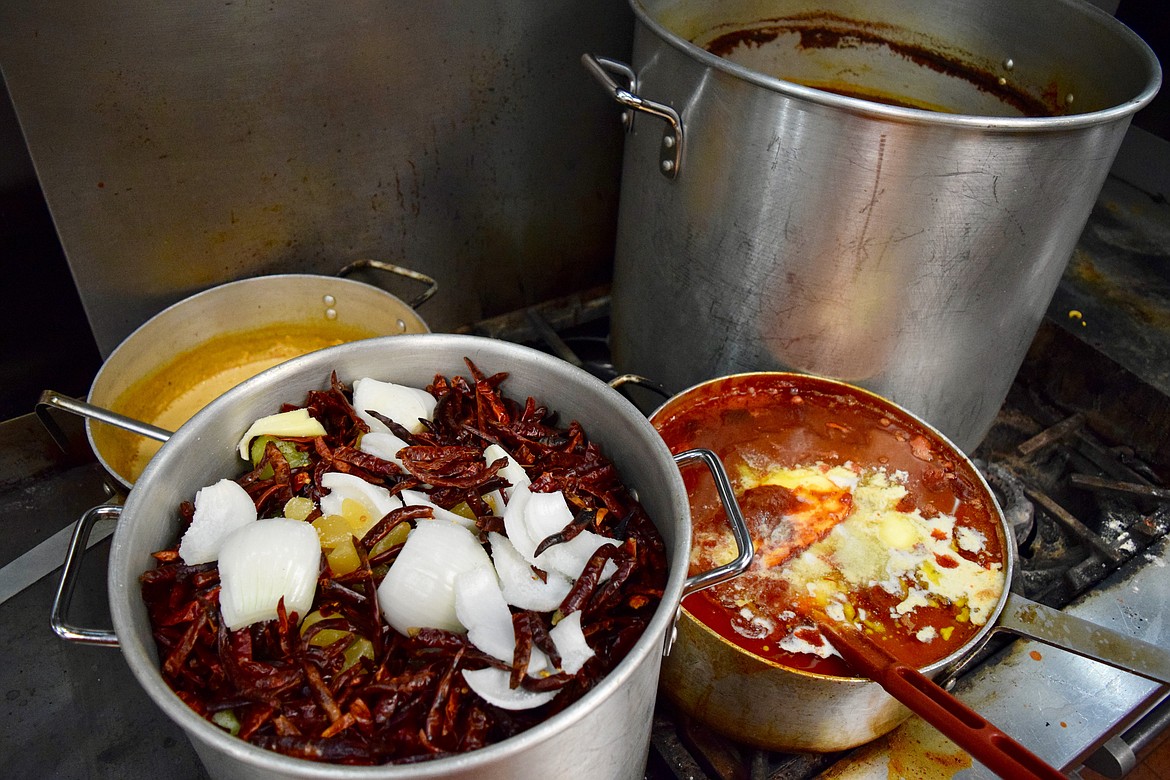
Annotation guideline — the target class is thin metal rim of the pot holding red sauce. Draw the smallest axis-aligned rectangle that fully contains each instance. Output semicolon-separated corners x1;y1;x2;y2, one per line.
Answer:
649;371;1019;685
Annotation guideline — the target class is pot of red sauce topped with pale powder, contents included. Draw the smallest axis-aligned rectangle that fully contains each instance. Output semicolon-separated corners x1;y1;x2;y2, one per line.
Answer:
651;372;1170;752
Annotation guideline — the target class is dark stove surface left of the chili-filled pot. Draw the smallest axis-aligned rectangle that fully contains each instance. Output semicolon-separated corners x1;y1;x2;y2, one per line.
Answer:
0;415;206;778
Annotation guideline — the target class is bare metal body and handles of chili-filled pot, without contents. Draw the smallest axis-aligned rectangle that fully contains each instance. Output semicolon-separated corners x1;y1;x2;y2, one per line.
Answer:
54;334;751;780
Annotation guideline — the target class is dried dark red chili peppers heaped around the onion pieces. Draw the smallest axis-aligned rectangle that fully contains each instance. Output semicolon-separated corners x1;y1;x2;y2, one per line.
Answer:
134;361;666;765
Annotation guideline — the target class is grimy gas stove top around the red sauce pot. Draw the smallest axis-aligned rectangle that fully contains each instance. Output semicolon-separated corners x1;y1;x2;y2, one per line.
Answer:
458;174;1170;780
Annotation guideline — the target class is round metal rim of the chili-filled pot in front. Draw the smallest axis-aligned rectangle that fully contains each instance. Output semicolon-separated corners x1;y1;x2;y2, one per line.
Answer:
109;333;690;780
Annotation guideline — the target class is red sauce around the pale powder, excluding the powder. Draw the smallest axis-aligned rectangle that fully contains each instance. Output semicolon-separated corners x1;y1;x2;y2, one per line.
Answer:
654;374;1004;676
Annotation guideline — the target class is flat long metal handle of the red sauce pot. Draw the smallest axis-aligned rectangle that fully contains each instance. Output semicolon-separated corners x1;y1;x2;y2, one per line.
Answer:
996;593;1170;685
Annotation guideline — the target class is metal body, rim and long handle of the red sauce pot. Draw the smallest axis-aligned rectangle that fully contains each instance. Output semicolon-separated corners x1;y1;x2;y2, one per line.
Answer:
652;372;1170;752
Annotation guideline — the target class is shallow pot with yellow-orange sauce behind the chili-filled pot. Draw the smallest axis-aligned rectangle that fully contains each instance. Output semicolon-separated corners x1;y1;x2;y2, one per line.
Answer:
85;274;429;488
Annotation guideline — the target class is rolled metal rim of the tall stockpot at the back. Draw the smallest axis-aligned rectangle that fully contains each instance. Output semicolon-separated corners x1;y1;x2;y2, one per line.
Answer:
628;0;1162;132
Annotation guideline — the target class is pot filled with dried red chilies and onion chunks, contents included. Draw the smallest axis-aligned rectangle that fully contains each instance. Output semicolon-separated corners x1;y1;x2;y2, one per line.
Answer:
91;334;751;778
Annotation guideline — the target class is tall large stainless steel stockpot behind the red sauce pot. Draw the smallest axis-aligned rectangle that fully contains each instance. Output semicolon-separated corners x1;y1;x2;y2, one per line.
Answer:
585;0;1161;451
